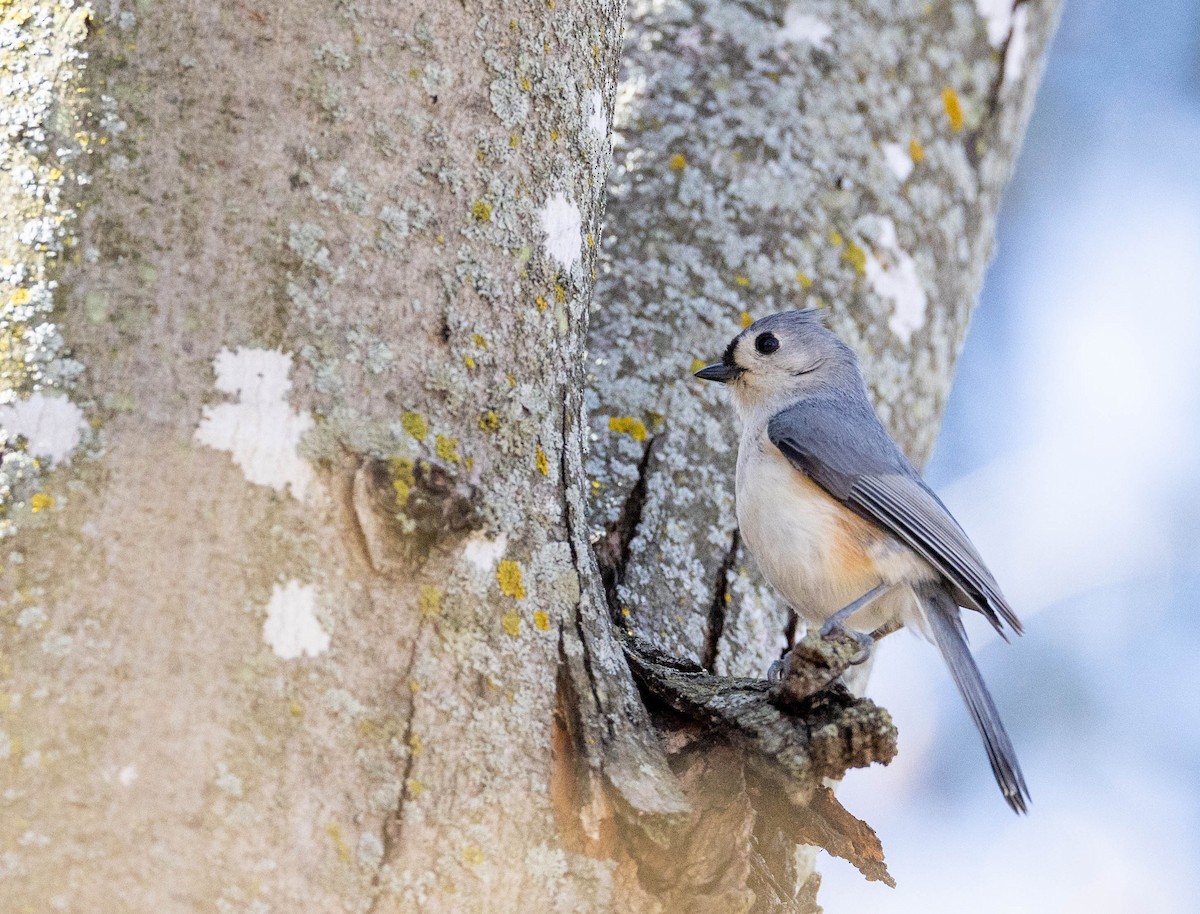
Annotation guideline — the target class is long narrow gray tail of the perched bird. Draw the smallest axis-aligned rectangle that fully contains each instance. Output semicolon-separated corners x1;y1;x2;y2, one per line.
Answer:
920;588;1030;812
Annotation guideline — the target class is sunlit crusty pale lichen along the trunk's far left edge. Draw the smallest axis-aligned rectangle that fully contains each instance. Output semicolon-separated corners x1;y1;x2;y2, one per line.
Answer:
0;0;94;536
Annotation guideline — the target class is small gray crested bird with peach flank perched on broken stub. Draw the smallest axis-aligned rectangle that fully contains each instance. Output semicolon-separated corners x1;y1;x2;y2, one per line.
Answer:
696;308;1030;812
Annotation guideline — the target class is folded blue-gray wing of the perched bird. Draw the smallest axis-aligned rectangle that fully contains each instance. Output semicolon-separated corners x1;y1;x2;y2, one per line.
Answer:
767;395;1021;635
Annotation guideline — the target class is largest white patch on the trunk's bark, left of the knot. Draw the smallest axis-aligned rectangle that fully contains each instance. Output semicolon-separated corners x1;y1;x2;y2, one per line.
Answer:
196;349;314;500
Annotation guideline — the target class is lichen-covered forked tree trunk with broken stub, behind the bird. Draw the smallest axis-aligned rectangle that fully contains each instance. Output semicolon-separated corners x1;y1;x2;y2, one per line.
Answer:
0;0;1052;914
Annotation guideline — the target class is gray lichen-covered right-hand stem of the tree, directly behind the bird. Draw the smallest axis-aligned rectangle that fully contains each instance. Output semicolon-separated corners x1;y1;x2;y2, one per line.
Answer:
587;0;1057;895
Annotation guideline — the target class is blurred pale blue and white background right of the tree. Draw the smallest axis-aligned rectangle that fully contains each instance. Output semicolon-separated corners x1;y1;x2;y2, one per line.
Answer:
820;0;1200;914
